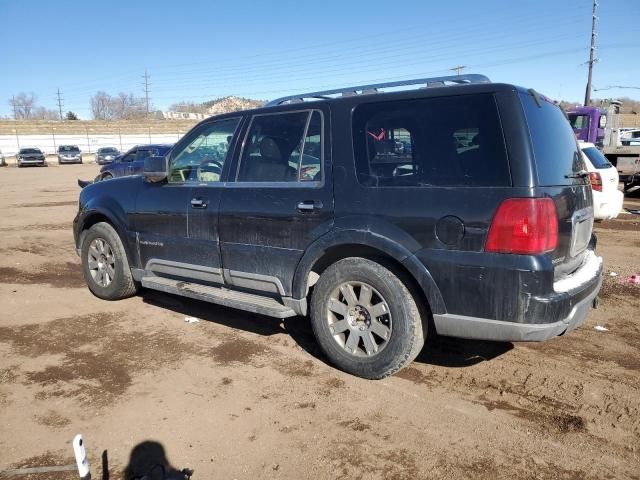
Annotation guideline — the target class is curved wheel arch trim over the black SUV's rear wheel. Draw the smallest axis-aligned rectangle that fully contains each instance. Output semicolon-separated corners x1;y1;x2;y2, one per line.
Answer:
292;229;446;313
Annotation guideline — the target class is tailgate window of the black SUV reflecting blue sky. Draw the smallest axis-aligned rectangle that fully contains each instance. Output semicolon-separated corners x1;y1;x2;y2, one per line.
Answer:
520;93;585;186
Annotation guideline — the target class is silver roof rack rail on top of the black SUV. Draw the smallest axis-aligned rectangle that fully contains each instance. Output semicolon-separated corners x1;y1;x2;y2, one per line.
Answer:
266;73;491;107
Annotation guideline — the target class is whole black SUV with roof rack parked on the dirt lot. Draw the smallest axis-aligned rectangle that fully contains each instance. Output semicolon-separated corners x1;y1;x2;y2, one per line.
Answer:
74;75;602;378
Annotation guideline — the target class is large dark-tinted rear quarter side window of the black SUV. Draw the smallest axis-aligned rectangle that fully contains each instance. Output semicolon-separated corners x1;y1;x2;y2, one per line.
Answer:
353;94;511;187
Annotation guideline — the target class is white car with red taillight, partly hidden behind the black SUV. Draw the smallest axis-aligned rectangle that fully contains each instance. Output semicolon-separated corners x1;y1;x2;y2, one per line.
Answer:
580;142;624;220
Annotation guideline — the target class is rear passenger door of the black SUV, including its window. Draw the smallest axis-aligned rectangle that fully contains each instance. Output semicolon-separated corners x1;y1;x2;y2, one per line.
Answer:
219;109;333;296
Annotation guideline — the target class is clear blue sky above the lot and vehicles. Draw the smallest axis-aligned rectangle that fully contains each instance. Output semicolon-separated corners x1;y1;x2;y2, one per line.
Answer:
0;0;640;119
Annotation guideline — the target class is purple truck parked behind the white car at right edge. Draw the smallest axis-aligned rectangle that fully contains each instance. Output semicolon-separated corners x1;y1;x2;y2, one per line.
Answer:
567;101;640;191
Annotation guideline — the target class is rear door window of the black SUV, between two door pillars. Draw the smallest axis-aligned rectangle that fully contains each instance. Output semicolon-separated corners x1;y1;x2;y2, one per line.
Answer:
237;111;322;183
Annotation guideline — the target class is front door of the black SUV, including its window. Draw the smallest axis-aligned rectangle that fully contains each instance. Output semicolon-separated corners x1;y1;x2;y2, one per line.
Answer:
136;117;241;284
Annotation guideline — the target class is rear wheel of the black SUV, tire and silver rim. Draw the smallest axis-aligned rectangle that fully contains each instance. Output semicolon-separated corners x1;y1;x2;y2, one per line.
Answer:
311;257;427;379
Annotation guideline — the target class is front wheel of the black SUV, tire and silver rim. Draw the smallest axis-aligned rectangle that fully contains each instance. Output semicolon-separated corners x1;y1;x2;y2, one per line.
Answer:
80;222;139;300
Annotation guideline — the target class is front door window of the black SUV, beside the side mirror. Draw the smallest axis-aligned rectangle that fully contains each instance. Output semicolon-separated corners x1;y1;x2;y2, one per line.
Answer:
169;117;240;183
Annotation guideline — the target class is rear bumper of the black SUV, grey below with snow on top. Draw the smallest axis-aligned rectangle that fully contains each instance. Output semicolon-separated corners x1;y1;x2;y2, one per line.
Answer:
433;252;602;342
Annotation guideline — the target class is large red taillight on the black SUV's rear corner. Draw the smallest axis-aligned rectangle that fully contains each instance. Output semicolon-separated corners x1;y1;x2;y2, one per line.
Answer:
485;198;558;254
